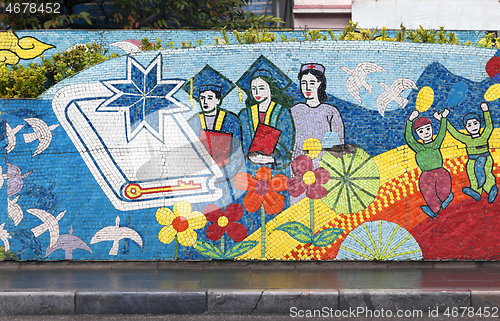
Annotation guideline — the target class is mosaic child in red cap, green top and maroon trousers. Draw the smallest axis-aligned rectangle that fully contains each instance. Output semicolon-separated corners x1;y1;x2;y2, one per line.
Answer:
405;109;453;217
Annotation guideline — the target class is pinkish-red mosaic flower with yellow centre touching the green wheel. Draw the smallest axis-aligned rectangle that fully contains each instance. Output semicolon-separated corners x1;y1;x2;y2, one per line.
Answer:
286;155;330;200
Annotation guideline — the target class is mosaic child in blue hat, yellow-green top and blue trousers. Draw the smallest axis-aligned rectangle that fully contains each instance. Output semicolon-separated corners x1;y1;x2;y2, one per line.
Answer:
448;103;498;204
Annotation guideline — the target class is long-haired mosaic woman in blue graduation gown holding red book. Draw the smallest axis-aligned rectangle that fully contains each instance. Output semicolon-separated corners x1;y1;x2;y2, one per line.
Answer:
239;69;294;176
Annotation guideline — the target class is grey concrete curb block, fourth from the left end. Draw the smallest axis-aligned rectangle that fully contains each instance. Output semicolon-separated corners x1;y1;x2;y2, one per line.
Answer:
339;289;470;312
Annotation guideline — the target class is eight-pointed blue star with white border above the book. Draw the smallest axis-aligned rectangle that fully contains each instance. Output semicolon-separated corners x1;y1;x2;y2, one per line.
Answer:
97;54;190;142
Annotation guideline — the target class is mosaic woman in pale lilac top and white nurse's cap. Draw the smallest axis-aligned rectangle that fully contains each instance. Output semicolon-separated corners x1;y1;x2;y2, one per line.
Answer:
291;63;345;204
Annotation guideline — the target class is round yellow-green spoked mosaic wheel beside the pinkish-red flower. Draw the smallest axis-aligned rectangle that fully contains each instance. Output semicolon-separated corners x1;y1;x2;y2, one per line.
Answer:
320;147;380;214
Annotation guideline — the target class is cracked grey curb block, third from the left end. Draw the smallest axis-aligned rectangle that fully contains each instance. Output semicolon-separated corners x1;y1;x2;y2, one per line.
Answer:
207;289;339;315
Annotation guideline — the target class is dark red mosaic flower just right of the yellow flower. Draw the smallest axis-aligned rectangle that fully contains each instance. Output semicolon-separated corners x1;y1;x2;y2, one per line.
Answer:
203;204;248;242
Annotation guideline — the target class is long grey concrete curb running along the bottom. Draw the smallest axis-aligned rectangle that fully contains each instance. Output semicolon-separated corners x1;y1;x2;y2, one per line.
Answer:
0;289;500;315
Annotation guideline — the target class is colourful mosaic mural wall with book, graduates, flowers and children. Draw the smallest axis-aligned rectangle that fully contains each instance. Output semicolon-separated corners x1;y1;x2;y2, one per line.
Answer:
0;31;500;260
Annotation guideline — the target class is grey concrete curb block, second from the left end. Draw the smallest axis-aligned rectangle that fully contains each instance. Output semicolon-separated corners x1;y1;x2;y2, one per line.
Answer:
75;291;207;314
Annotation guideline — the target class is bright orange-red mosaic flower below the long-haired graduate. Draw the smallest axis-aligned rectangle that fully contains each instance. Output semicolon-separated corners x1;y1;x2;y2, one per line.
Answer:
234;167;288;215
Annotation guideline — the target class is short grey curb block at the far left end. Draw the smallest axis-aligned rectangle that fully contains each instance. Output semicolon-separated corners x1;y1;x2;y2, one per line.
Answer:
0;291;75;315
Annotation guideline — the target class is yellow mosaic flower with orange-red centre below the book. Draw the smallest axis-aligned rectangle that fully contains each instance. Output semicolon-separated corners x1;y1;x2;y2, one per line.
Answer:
156;201;207;246
